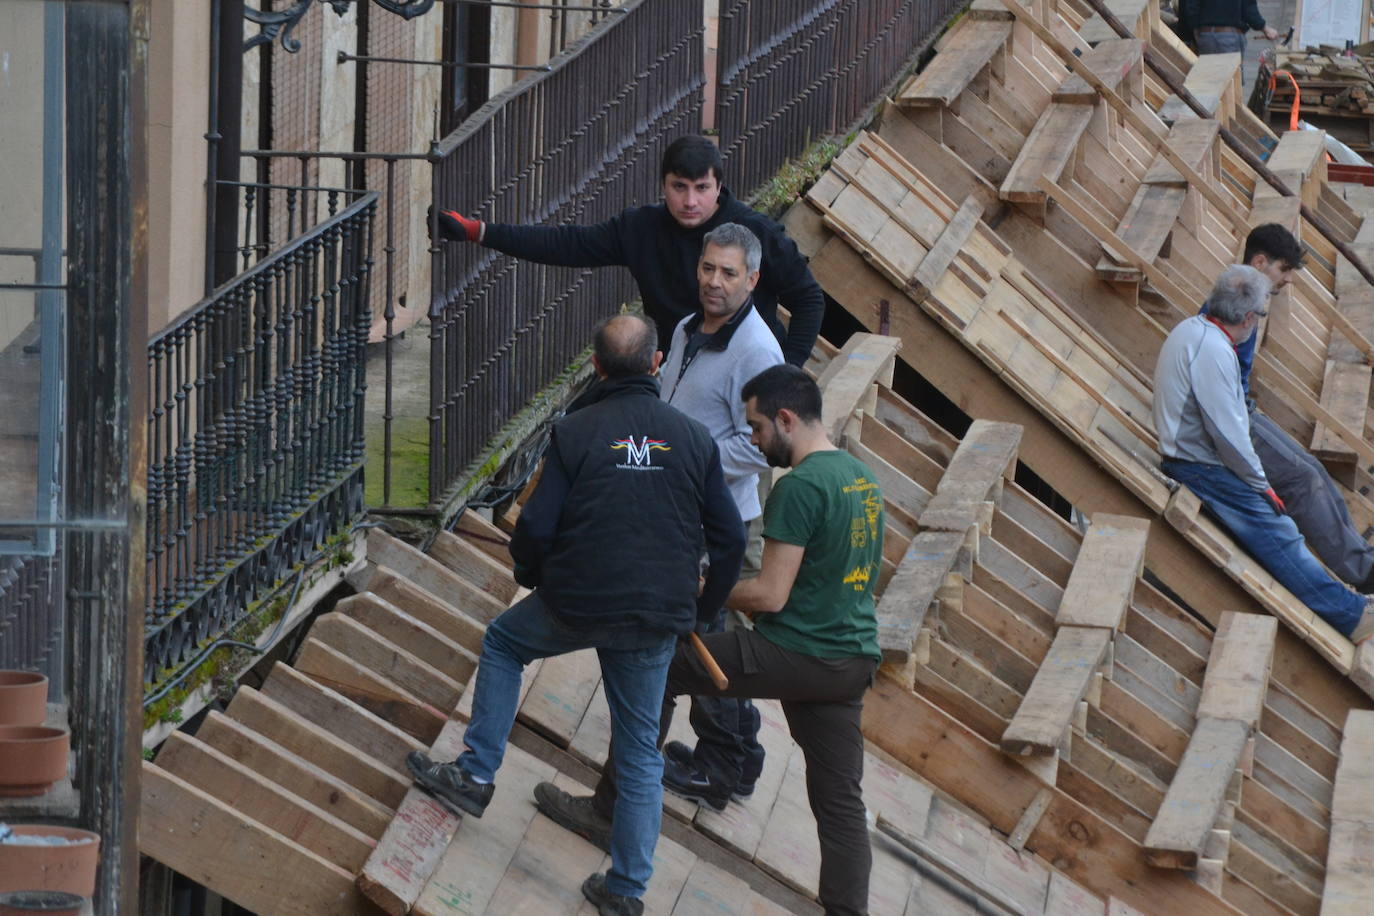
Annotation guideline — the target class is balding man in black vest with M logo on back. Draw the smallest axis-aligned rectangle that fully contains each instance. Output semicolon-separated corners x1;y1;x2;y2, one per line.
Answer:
405;314;745;916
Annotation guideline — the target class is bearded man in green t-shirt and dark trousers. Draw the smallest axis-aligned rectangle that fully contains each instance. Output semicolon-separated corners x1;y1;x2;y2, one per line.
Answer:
540;364;883;916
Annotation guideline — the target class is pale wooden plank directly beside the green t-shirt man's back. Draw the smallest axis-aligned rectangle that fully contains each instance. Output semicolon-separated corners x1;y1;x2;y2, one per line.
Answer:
877;531;965;665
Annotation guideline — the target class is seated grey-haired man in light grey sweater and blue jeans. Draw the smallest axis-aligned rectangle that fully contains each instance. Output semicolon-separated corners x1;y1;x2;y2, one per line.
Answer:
1154;265;1374;643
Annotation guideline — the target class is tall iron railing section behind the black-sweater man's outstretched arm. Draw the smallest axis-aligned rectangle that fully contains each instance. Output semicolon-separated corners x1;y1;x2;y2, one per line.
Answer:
429;0;703;505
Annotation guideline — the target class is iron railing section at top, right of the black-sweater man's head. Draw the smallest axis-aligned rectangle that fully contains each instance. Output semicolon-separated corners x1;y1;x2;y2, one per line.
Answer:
716;0;967;197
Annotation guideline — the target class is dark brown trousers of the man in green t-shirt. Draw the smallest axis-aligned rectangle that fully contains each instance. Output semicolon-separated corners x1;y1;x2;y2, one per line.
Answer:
595;630;878;916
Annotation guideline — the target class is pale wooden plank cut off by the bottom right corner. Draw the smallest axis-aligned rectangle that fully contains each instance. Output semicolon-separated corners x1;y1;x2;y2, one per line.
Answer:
1322;710;1374;916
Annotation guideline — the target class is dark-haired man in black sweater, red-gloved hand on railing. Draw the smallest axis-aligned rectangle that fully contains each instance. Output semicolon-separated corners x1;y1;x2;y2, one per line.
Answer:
437;135;826;365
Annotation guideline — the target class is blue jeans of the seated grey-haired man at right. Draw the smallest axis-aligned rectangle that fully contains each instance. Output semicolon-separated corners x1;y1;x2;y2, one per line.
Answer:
1160;459;1364;636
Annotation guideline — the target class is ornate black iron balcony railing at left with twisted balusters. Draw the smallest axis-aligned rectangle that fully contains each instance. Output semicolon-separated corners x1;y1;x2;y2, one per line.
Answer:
144;184;378;684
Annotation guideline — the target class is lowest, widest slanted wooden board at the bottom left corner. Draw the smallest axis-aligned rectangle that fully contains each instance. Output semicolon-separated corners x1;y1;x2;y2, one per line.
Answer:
139;761;363;916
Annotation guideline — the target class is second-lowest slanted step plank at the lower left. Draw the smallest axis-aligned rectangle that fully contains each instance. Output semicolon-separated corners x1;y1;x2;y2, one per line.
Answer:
157;732;374;872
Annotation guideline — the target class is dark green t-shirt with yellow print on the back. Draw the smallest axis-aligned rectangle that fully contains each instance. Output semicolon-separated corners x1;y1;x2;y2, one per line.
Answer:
754;450;883;659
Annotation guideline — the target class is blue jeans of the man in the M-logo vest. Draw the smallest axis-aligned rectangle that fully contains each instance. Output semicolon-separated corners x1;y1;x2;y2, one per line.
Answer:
458;591;677;897
